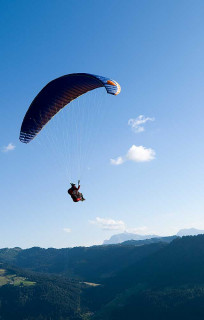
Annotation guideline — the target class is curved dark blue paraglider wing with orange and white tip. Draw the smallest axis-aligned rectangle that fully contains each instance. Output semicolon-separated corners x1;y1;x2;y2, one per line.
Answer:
19;73;120;143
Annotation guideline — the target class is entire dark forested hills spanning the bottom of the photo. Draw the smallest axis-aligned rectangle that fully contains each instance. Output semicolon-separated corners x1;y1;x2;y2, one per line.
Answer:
0;235;204;320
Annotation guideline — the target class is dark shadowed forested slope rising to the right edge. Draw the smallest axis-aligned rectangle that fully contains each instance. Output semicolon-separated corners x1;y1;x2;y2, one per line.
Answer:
83;235;204;320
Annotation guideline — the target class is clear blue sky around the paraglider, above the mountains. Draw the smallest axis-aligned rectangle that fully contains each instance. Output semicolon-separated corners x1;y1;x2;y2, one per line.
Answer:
0;0;204;248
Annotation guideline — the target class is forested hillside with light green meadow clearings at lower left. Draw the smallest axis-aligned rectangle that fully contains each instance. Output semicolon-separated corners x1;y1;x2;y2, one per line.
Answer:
0;264;83;320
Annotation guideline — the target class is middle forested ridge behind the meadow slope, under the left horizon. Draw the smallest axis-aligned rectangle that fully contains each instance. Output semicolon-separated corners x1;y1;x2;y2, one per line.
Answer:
0;240;166;282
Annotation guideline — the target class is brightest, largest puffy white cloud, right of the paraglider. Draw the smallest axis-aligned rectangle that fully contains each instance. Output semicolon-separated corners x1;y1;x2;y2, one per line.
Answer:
110;144;156;165
